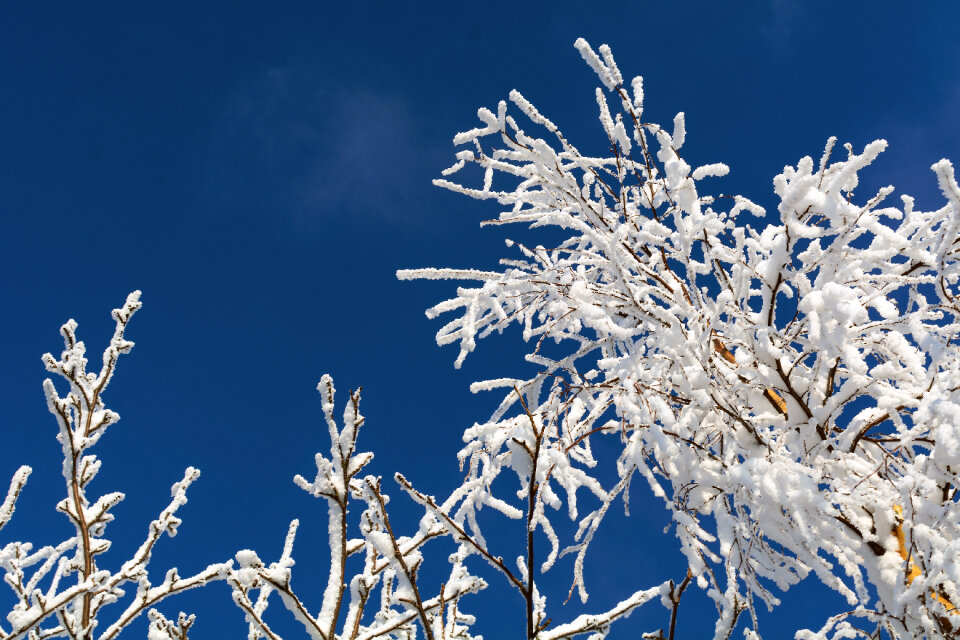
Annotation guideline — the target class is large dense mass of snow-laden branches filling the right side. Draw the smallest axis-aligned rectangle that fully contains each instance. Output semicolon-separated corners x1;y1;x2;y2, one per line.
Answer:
398;39;960;639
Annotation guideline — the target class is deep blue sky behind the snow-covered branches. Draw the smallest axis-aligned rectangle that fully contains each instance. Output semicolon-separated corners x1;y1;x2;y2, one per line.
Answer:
0;5;960;639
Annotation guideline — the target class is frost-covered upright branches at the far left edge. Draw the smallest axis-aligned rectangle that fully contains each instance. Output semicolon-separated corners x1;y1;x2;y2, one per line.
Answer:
0;291;227;640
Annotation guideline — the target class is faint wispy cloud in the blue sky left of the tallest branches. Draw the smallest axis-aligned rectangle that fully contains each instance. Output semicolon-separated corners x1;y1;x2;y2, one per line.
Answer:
208;68;447;224
